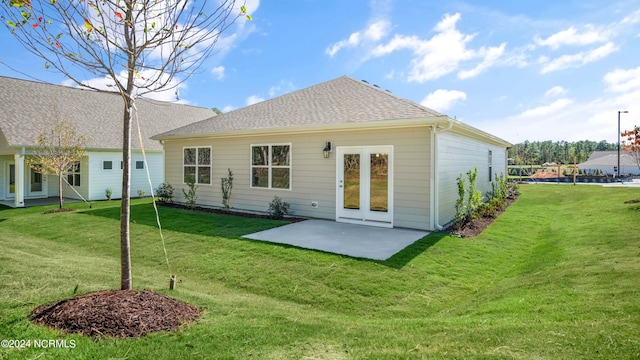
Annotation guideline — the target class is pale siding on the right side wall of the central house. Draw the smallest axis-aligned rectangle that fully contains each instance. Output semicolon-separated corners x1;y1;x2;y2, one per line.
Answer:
438;132;507;225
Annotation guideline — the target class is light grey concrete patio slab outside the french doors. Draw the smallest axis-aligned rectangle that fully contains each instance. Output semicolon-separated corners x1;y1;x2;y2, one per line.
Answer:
243;220;429;260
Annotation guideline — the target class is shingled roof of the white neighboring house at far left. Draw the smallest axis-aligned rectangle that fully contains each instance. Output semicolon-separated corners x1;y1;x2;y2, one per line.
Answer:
0;76;214;150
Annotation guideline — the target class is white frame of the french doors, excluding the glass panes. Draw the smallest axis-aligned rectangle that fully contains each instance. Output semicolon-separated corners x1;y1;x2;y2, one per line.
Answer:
336;145;394;227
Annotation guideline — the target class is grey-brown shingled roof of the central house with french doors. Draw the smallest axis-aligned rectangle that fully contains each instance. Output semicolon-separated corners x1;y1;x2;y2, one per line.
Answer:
154;76;442;139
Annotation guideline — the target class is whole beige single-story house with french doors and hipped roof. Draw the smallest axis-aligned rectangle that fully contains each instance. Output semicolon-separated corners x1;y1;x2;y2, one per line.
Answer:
153;76;511;230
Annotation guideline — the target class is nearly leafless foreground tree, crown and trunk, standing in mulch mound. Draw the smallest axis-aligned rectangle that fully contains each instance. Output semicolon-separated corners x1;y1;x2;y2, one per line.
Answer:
0;0;251;290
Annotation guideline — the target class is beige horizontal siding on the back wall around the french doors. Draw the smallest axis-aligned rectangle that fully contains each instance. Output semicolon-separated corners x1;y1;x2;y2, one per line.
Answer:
165;127;430;229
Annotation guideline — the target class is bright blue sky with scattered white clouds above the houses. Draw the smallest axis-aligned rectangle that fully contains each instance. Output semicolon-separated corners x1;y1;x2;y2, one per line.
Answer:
0;0;640;143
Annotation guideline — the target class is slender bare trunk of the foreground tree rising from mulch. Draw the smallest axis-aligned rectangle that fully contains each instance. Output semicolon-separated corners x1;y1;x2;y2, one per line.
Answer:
120;97;133;290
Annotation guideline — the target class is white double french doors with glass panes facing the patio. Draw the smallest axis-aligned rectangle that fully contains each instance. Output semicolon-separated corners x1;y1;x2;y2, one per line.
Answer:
336;146;393;227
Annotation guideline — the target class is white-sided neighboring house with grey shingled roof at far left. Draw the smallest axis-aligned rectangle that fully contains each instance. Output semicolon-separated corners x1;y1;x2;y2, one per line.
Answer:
0;77;213;207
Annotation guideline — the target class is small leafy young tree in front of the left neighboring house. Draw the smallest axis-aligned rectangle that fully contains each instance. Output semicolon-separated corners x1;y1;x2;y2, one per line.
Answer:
29;119;86;209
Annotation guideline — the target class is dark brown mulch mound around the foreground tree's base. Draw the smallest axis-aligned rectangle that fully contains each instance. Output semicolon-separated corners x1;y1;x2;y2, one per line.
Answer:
31;290;202;338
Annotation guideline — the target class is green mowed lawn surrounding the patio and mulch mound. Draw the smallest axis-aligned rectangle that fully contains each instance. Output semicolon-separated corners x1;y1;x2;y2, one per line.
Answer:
0;185;640;359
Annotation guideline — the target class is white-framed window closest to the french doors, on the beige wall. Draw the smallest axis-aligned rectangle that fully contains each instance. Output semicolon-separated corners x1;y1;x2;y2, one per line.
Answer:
251;144;291;189
